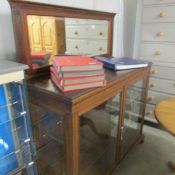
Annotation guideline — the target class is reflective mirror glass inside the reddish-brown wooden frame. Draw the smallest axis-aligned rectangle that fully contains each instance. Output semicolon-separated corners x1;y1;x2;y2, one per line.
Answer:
27;15;108;69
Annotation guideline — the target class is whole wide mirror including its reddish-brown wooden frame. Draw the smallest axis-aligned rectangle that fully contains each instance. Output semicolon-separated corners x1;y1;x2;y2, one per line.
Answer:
8;0;115;78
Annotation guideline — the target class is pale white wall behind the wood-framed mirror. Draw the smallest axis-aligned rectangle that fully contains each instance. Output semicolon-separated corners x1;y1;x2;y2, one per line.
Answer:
0;0;122;60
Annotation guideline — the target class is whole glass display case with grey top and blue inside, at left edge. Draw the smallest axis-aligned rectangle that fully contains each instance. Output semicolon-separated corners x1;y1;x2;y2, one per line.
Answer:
0;60;36;175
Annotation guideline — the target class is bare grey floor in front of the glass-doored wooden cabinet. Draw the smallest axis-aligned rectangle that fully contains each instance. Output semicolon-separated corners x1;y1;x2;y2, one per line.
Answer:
113;126;175;175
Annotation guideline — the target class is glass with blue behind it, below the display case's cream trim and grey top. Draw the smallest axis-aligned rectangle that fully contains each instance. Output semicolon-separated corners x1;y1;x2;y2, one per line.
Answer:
0;82;33;175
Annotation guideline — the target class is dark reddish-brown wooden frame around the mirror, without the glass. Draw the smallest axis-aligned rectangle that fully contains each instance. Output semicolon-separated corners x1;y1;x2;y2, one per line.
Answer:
8;0;115;78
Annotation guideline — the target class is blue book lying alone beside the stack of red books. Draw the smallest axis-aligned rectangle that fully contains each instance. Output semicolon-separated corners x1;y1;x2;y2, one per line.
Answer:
95;56;148;70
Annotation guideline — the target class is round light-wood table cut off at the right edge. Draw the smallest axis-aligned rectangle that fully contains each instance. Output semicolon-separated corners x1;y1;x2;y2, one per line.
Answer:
155;97;175;172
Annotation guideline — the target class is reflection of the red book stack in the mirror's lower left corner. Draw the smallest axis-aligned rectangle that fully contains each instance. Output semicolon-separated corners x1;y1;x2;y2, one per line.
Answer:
31;51;51;68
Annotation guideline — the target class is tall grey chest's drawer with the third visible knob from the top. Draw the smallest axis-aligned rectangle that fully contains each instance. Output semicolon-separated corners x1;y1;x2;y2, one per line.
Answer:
140;43;175;63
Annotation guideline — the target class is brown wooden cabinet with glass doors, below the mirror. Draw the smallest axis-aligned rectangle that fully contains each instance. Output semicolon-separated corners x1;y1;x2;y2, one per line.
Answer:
28;65;151;175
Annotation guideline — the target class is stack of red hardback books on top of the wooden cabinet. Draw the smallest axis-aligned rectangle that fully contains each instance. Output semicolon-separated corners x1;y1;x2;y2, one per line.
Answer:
50;56;106;92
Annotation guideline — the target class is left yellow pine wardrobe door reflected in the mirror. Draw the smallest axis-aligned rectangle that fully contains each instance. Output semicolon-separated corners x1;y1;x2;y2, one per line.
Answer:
27;15;42;51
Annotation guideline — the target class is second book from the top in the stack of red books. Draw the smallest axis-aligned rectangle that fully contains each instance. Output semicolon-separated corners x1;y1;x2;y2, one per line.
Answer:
58;70;104;78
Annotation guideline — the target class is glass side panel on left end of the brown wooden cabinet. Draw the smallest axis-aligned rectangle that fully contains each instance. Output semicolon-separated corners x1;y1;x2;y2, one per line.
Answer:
31;105;65;175
